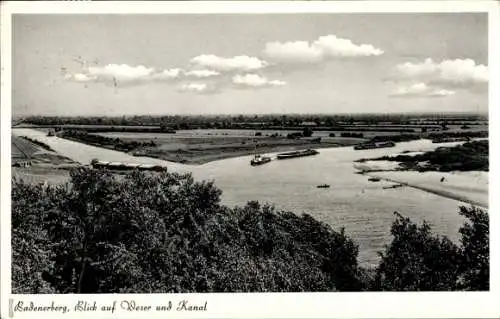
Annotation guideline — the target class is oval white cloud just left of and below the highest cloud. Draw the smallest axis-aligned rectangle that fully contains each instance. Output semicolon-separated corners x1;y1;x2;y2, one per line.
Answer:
191;54;268;72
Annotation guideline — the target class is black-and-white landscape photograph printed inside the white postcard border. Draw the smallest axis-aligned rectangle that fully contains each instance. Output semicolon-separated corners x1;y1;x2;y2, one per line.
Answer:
5;1;490;302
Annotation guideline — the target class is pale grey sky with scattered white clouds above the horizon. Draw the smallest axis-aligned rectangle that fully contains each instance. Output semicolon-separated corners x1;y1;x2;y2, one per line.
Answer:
12;13;488;116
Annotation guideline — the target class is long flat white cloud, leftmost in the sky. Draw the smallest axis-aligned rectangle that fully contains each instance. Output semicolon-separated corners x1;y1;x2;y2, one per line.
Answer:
66;64;182;83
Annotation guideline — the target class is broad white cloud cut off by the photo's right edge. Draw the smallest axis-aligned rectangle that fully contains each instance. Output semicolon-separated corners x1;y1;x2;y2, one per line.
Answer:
393;58;488;88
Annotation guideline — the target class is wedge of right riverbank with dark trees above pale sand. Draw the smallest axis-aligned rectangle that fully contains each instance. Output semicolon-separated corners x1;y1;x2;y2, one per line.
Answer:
354;140;489;208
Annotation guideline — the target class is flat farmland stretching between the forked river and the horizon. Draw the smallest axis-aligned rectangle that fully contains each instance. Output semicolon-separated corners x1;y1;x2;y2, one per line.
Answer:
16;114;488;164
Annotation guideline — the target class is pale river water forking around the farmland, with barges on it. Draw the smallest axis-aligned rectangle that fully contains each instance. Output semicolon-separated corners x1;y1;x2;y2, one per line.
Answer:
12;129;480;266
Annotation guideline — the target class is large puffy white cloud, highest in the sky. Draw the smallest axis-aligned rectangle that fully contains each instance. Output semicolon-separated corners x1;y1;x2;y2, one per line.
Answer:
263;35;384;63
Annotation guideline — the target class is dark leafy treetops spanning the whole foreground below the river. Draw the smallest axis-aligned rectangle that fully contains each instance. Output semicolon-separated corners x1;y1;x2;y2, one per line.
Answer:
12;168;489;294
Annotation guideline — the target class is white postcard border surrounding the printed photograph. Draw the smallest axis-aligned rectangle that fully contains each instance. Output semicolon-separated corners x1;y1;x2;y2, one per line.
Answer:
0;1;500;318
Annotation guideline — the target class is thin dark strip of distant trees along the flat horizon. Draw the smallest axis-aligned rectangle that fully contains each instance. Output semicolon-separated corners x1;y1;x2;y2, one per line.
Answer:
23;114;487;133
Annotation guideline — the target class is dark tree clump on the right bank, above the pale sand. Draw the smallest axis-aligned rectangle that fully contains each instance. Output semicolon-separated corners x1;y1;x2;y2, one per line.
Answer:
368;140;489;172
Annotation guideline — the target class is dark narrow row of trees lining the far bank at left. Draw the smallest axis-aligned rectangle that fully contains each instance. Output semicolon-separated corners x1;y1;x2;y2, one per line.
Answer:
59;130;156;152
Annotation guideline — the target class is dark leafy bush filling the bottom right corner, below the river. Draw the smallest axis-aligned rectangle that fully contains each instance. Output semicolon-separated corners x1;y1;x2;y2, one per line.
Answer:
372;206;489;291
